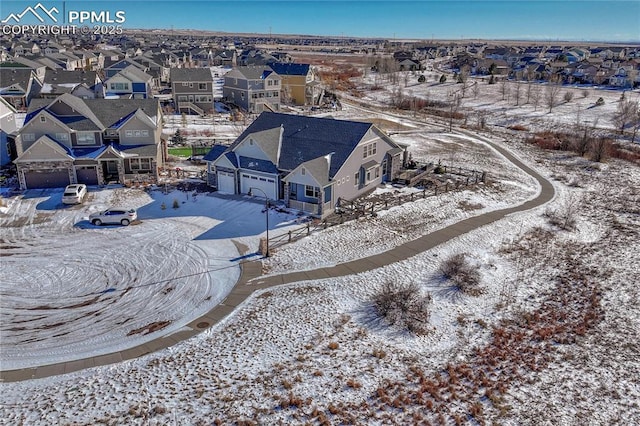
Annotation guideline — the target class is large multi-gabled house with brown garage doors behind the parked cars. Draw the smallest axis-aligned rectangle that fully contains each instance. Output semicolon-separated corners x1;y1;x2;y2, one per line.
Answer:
14;94;165;189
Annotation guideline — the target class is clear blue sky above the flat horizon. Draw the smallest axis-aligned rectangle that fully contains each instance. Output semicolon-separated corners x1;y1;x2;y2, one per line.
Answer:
0;0;640;42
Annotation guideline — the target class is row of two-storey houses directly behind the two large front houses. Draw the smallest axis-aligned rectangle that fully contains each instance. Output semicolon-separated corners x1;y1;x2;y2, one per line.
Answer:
0;52;320;115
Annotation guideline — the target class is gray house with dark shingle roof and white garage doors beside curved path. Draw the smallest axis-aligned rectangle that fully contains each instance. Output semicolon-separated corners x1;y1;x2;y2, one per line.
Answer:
204;112;406;217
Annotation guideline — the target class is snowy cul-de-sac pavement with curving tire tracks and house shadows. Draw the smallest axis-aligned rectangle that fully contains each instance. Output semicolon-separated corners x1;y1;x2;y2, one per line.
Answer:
0;187;296;370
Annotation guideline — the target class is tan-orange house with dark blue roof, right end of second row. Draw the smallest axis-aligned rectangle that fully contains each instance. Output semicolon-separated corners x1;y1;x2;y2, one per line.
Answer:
269;62;321;105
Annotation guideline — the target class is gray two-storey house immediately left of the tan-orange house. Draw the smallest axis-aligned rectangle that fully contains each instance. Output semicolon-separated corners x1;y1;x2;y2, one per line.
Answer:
223;66;282;113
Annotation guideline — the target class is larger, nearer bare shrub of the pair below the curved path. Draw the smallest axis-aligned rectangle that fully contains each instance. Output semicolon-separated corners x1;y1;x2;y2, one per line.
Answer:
373;282;431;335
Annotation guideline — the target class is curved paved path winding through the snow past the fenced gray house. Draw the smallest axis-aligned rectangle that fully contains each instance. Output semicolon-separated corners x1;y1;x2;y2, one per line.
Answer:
0;135;555;382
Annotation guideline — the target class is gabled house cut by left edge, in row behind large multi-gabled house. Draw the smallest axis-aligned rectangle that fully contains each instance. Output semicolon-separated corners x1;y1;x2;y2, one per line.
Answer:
0;67;41;111
